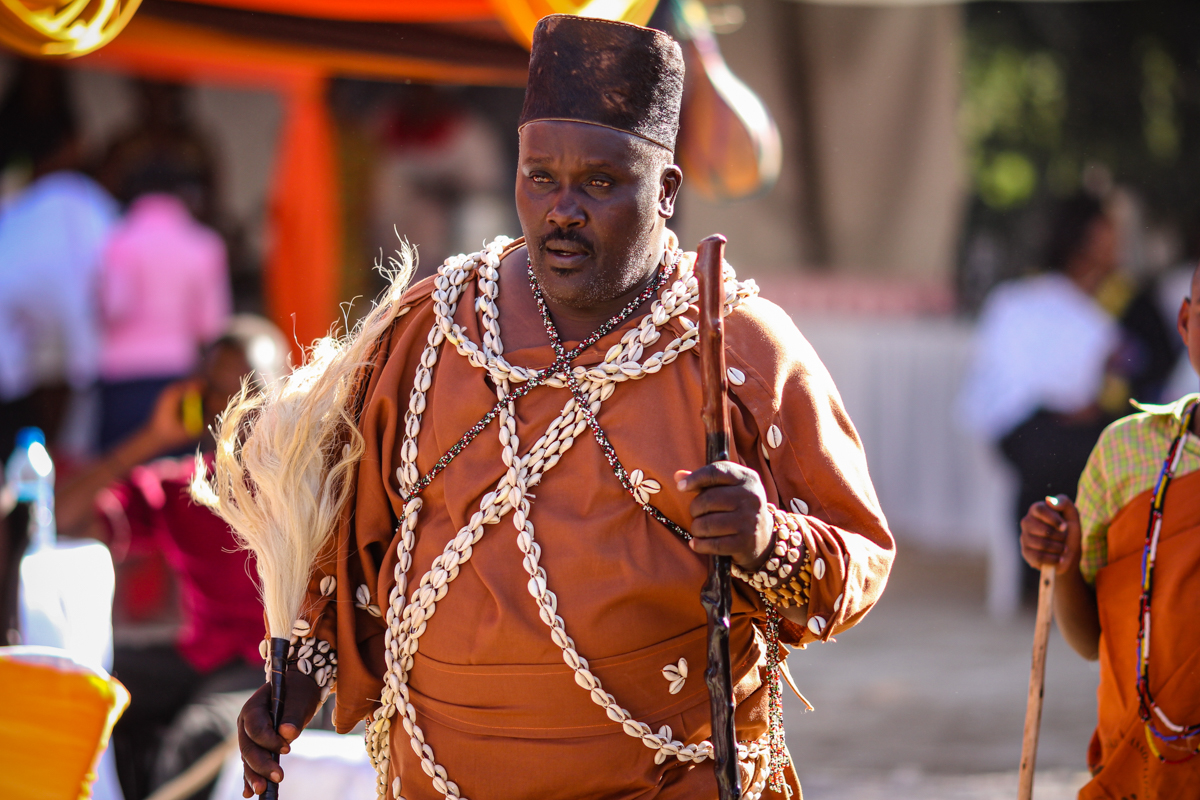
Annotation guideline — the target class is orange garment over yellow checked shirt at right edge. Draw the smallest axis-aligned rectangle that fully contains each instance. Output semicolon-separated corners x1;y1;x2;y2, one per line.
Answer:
1079;471;1200;800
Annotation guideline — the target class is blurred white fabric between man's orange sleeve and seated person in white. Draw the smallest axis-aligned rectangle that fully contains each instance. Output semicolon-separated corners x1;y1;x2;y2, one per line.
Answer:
794;314;1020;618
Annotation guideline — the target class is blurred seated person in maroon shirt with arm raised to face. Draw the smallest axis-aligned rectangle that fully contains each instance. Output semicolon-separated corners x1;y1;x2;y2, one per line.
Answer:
58;317;287;800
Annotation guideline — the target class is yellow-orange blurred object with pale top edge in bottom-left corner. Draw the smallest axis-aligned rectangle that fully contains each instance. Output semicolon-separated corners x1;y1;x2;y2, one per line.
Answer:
0;646;130;800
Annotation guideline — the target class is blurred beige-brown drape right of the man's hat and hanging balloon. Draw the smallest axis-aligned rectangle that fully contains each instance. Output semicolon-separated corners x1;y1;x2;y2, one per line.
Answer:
676;0;965;285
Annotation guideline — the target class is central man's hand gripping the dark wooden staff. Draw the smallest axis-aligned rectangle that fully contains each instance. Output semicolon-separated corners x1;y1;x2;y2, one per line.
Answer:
676;461;774;572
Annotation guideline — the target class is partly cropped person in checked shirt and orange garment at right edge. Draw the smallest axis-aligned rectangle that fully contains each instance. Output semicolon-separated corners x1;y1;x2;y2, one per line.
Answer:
1021;262;1200;800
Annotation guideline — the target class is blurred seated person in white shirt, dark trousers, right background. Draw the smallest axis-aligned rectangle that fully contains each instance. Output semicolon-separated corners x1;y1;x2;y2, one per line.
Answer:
959;194;1129;599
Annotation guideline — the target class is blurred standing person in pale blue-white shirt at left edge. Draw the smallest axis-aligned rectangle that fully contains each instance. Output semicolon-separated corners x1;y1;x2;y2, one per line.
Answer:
0;61;118;457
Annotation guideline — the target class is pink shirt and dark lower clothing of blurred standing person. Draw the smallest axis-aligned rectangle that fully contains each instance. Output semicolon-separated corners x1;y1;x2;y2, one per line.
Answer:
100;181;230;452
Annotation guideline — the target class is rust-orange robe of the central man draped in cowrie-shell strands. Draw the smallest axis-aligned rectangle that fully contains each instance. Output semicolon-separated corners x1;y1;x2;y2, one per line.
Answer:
297;242;894;800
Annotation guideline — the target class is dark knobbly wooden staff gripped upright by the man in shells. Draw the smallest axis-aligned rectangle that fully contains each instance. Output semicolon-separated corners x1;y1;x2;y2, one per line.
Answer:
696;234;742;800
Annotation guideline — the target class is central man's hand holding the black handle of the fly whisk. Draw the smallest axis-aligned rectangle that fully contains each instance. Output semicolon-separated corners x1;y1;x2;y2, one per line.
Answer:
238;669;320;798
